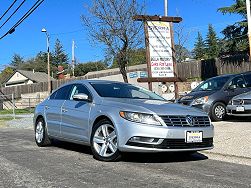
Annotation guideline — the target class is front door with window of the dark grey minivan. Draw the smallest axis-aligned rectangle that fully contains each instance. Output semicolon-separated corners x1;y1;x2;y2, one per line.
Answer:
226;75;248;101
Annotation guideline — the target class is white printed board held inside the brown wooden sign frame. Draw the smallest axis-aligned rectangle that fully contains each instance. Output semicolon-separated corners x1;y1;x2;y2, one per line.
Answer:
147;21;174;78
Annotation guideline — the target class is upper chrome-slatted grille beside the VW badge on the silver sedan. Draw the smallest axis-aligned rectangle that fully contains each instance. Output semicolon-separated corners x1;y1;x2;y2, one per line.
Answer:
160;116;210;127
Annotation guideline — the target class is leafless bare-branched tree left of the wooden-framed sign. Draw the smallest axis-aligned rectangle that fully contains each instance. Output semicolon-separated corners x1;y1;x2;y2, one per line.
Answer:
82;0;143;82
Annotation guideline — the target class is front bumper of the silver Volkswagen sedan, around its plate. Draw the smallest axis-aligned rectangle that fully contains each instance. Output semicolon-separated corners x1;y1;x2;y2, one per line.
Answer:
116;120;214;152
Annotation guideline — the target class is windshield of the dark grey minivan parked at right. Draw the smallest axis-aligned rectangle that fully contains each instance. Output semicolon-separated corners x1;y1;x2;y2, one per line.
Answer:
193;76;230;91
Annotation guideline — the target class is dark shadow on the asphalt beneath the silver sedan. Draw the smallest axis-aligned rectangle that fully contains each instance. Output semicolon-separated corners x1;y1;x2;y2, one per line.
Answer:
52;140;208;163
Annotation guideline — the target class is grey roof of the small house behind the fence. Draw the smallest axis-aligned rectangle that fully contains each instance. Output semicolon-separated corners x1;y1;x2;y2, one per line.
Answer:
5;70;55;83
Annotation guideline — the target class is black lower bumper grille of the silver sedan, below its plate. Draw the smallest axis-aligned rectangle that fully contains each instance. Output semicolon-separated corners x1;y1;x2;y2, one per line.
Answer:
127;138;213;149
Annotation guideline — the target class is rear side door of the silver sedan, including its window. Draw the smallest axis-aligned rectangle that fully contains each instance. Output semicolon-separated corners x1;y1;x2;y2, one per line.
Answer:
44;85;71;137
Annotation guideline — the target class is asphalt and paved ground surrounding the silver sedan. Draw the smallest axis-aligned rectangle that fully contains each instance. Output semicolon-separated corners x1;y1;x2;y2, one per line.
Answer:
0;119;251;188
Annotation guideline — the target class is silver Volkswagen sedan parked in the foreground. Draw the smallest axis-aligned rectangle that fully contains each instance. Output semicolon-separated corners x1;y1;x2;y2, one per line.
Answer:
34;80;214;161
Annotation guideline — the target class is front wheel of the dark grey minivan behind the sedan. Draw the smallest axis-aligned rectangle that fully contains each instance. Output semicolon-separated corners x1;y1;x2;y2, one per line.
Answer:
210;102;226;121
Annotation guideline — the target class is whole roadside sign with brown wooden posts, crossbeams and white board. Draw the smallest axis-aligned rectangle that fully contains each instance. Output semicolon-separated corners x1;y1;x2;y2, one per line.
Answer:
133;15;185;98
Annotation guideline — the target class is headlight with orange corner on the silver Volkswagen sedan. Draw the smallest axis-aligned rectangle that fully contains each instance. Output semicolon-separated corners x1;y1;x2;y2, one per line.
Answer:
119;111;162;126
